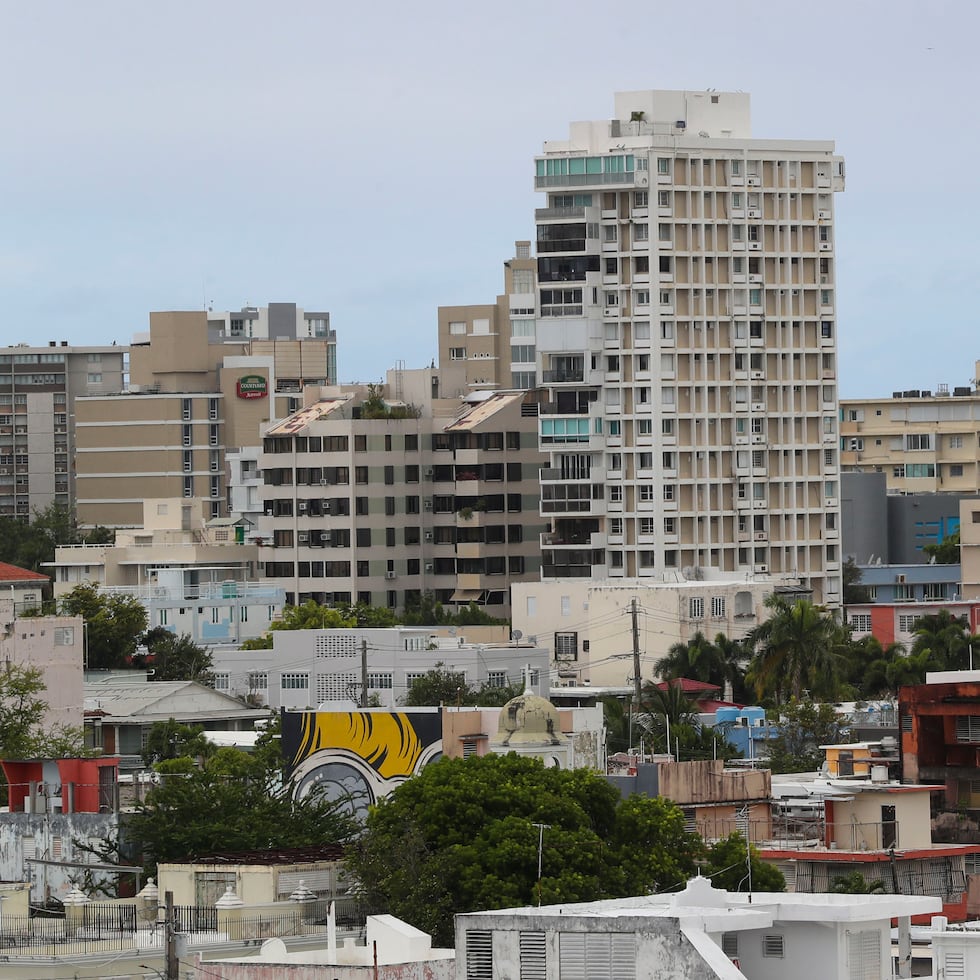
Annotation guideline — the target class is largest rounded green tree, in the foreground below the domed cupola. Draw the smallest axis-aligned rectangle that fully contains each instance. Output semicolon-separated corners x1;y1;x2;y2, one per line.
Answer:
348;754;701;945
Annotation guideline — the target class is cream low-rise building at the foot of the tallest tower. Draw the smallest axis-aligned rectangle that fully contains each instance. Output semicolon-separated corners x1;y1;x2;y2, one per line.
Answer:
511;573;797;687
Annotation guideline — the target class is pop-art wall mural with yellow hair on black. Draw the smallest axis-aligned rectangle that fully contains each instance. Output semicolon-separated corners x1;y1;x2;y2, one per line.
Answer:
282;711;442;813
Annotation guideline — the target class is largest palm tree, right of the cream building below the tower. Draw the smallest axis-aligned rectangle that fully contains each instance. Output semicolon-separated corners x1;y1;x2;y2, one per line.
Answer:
747;593;848;701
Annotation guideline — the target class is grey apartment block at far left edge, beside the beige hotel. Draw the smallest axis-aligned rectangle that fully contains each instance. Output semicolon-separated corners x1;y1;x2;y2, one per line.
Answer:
0;340;128;520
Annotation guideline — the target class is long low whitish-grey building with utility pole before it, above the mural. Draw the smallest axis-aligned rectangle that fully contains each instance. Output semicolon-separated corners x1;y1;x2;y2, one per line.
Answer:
212;626;549;709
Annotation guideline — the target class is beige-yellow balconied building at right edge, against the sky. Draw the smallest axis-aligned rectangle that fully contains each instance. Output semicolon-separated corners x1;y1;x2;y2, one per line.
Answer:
841;361;980;494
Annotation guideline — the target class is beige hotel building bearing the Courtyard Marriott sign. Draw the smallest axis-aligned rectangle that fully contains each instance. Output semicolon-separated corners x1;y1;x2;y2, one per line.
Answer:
76;303;336;527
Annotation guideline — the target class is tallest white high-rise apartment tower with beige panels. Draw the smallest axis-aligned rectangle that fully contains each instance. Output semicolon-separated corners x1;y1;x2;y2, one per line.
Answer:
535;91;844;604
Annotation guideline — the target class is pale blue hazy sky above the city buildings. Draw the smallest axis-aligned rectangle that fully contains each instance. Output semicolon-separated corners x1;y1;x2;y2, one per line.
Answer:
0;0;980;397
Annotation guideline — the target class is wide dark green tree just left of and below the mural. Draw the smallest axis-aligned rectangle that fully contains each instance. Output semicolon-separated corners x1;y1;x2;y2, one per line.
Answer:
126;736;357;874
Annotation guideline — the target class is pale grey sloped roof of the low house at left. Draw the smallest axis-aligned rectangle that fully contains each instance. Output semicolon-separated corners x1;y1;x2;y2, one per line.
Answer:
85;678;268;721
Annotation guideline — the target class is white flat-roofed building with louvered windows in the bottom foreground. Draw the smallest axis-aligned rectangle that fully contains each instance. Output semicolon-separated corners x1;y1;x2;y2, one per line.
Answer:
456;878;940;980
